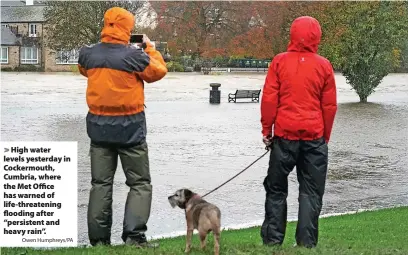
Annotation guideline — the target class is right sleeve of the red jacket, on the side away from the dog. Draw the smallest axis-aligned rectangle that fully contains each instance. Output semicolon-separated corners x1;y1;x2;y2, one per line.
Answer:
321;64;337;143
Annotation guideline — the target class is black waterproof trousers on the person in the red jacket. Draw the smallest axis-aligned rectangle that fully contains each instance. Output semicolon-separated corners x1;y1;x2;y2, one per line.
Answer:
261;137;328;248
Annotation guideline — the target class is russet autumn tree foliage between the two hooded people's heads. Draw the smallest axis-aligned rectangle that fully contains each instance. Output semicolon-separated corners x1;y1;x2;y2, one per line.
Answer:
150;1;326;59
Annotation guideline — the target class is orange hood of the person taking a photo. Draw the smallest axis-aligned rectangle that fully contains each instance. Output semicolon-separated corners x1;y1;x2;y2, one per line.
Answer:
101;7;135;44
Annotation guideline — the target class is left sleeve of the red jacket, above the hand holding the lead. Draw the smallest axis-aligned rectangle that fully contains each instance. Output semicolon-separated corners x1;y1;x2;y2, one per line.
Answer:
261;56;280;136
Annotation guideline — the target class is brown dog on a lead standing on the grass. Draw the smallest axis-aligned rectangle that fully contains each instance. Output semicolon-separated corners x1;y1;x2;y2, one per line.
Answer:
168;189;221;255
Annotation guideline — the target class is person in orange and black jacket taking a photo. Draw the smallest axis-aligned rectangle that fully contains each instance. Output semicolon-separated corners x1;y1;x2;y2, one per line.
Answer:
78;7;167;247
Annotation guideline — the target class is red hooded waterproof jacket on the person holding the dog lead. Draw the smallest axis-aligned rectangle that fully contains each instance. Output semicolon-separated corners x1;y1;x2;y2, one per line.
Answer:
261;16;337;143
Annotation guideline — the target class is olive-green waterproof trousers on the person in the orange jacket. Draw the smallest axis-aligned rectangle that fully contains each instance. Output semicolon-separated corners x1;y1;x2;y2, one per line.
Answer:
88;142;152;245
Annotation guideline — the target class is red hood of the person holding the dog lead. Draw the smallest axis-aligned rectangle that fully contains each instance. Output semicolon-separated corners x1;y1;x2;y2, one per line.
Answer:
288;16;322;53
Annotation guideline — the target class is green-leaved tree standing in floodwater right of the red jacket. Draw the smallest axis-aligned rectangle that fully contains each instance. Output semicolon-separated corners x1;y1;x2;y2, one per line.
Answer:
317;1;408;102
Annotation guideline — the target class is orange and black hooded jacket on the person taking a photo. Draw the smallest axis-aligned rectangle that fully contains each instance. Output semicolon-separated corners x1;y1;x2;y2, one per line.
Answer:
78;7;167;145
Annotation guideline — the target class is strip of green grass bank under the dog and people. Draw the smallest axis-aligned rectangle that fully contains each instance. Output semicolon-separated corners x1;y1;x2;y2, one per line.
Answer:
1;207;408;255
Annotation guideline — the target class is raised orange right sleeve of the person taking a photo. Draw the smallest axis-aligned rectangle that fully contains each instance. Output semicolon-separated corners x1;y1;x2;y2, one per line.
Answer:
137;43;167;83
